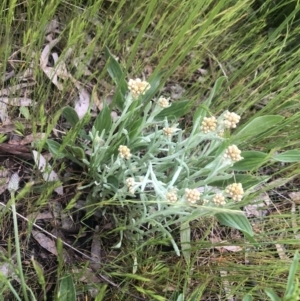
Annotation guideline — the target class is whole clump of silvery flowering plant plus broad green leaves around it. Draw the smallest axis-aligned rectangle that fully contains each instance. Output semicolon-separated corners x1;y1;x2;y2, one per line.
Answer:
47;50;292;261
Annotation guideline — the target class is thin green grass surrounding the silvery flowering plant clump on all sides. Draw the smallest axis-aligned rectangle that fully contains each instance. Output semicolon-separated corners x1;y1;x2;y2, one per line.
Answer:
0;0;300;300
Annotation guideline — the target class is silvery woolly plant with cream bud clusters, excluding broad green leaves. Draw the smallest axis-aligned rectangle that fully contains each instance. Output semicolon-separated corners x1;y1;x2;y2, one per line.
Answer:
83;79;248;255
